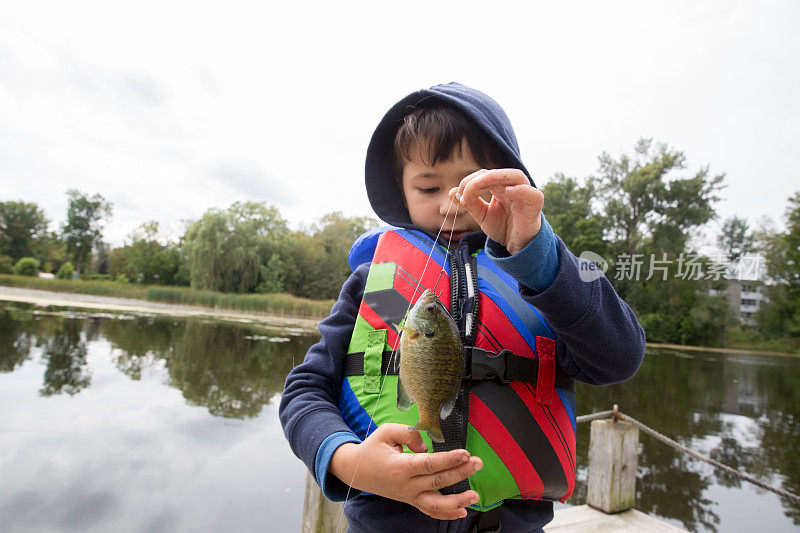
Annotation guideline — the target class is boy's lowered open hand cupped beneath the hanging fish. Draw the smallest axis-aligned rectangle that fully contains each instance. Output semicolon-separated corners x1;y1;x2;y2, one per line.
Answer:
329;424;483;520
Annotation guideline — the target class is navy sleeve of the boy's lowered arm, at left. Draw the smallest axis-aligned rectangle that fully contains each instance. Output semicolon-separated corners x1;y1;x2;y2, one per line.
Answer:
278;264;369;501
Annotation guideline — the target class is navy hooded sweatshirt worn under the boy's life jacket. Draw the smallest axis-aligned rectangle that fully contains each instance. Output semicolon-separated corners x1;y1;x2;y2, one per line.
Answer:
280;83;645;533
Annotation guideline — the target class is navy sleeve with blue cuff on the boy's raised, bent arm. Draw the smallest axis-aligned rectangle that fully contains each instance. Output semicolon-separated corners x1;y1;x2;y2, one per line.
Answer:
487;218;645;385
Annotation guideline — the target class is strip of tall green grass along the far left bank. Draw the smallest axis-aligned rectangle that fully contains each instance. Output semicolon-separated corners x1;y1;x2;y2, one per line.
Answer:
0;274;333;318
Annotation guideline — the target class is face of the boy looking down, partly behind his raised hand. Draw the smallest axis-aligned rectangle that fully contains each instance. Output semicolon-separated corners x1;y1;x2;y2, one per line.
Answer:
402;141;488;244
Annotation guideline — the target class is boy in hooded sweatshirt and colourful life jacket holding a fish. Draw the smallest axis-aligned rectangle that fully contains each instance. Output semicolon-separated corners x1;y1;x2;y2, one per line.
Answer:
280;83;644;532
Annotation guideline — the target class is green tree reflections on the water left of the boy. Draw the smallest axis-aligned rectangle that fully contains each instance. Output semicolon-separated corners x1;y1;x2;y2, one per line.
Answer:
0;306;314;418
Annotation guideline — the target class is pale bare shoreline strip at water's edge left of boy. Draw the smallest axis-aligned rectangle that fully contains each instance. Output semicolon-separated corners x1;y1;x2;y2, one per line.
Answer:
0;285;322;333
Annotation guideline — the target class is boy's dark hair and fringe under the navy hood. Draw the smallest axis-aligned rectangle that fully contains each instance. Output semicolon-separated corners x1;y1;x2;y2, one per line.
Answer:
393;102;506;183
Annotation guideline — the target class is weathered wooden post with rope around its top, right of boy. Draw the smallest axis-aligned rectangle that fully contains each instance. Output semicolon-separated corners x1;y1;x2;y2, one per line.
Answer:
586;420;639;513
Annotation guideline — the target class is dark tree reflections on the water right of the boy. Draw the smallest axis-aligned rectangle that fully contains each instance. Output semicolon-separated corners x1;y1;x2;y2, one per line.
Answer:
577;350;800;531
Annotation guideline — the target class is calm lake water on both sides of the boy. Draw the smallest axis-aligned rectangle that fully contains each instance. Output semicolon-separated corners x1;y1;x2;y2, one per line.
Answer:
0;302;800;532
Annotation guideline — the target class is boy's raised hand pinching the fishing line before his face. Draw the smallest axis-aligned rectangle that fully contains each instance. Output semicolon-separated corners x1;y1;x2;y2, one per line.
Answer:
449;168;544;255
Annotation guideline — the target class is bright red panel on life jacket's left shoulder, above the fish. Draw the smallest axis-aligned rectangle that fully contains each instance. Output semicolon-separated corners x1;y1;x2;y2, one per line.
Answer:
372;231;450;310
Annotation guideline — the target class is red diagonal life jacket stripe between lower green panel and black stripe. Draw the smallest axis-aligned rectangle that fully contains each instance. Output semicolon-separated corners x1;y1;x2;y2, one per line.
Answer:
469;393;544;498
